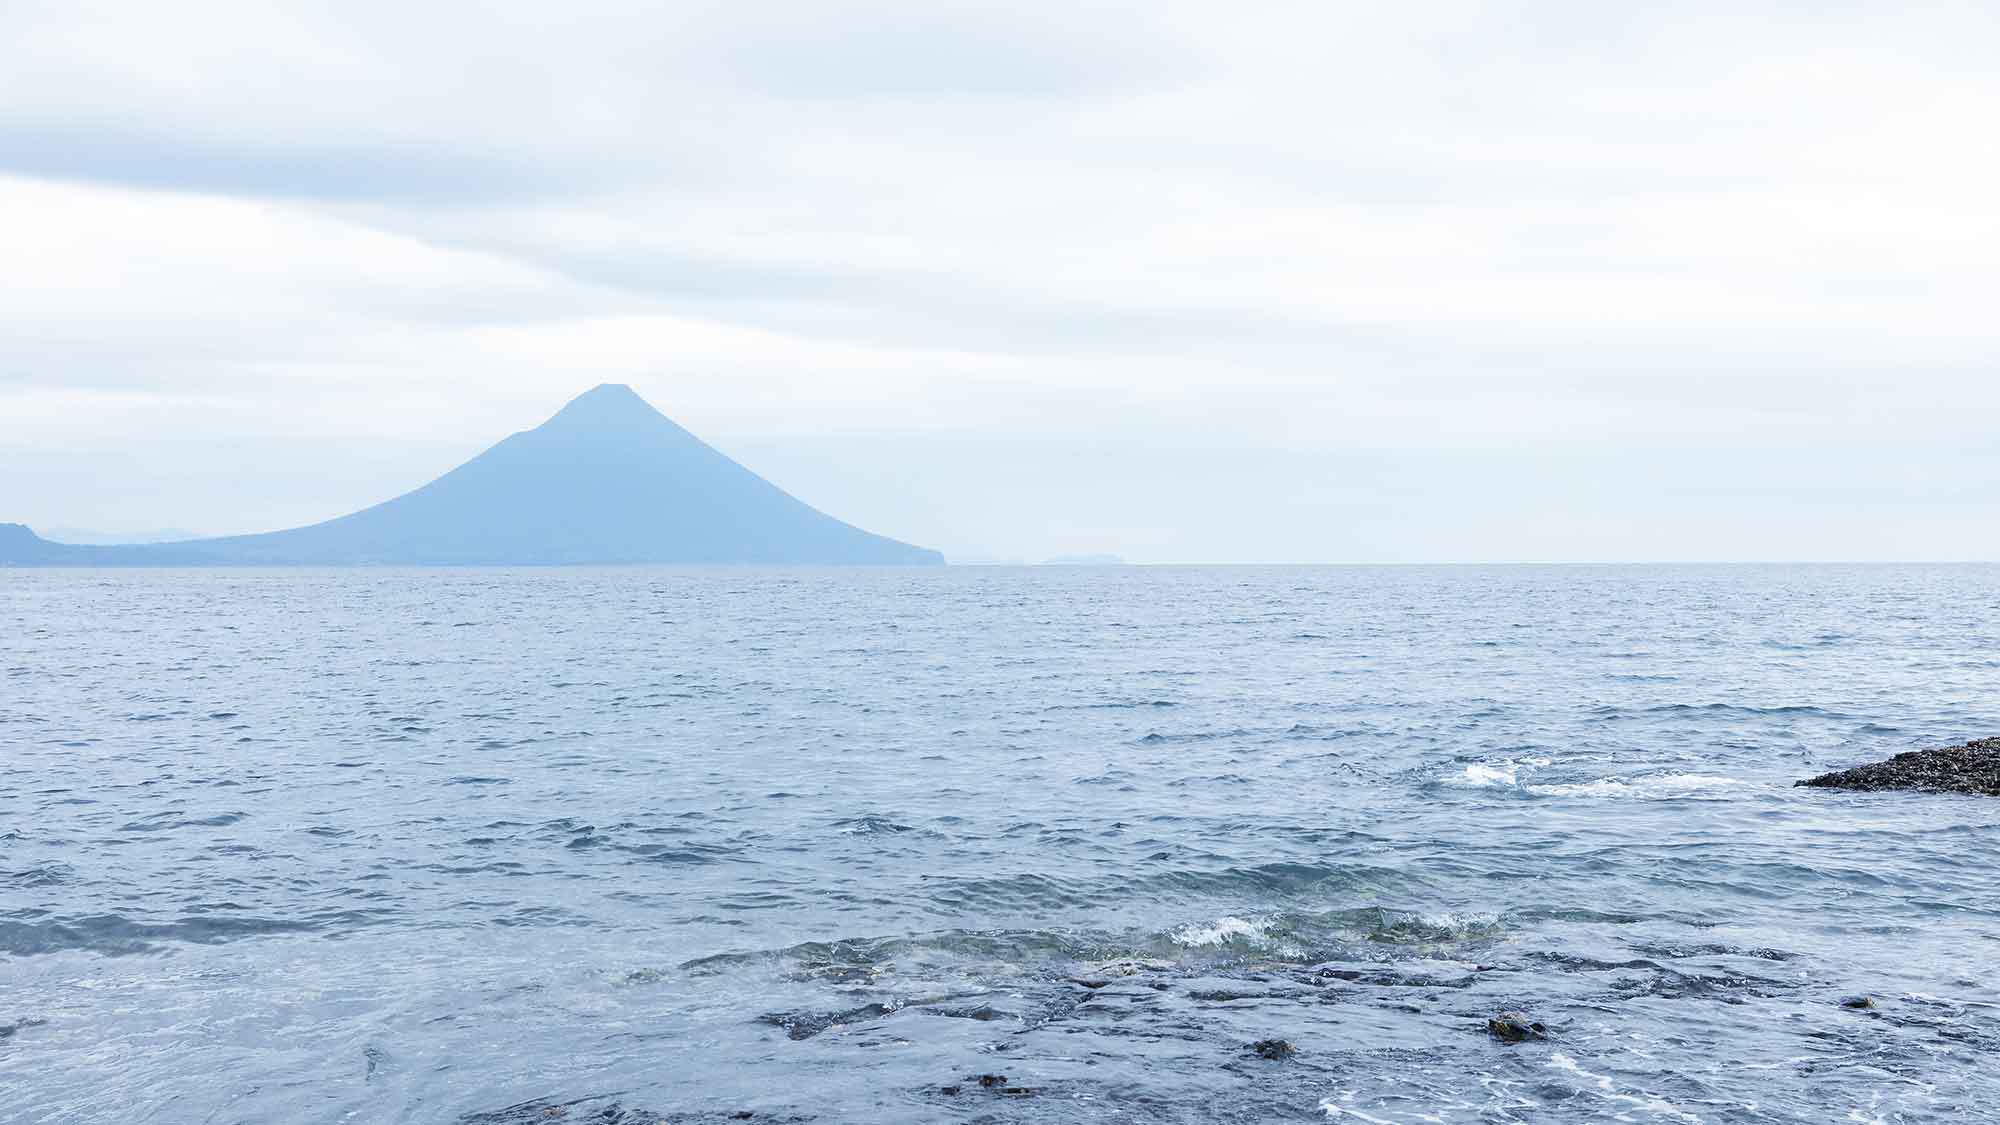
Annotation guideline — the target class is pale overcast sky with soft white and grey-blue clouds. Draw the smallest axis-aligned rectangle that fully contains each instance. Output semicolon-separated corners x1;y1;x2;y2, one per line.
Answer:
0;0;2000;563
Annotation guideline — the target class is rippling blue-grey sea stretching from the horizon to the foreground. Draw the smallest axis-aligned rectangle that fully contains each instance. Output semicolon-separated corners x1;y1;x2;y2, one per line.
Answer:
0;567;2000;1125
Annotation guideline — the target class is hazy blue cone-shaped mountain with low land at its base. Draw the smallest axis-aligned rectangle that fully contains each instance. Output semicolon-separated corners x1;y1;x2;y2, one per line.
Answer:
0;384;944;567
